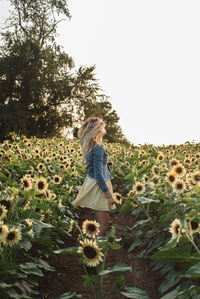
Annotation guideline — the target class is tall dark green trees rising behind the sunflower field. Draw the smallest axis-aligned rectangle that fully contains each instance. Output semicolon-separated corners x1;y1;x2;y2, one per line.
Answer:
0;0;128;143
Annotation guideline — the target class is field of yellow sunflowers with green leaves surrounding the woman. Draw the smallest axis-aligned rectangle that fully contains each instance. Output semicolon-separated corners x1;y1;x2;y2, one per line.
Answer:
0;134;200;299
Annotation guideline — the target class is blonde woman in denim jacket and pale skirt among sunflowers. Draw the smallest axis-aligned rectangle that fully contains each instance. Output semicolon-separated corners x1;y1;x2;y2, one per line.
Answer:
72;117;116;236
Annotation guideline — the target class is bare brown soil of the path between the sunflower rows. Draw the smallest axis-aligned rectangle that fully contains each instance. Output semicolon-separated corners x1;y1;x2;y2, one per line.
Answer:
39;210;161;299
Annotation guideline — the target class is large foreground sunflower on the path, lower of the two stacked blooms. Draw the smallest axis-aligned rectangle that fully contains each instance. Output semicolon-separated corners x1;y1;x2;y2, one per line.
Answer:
78;239;103;267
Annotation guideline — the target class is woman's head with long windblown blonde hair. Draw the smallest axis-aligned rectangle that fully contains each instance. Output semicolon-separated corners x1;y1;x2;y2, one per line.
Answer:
78;117;106;156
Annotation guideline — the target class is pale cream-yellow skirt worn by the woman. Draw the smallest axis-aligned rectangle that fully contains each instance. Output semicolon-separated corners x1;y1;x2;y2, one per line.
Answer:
72;176;116;211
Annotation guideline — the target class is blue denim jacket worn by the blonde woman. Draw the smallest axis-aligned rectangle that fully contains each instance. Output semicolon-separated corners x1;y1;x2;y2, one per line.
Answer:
85;144;112;192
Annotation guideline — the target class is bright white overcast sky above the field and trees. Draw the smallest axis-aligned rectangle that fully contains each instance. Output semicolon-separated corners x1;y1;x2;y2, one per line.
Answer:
0;0;200;145
